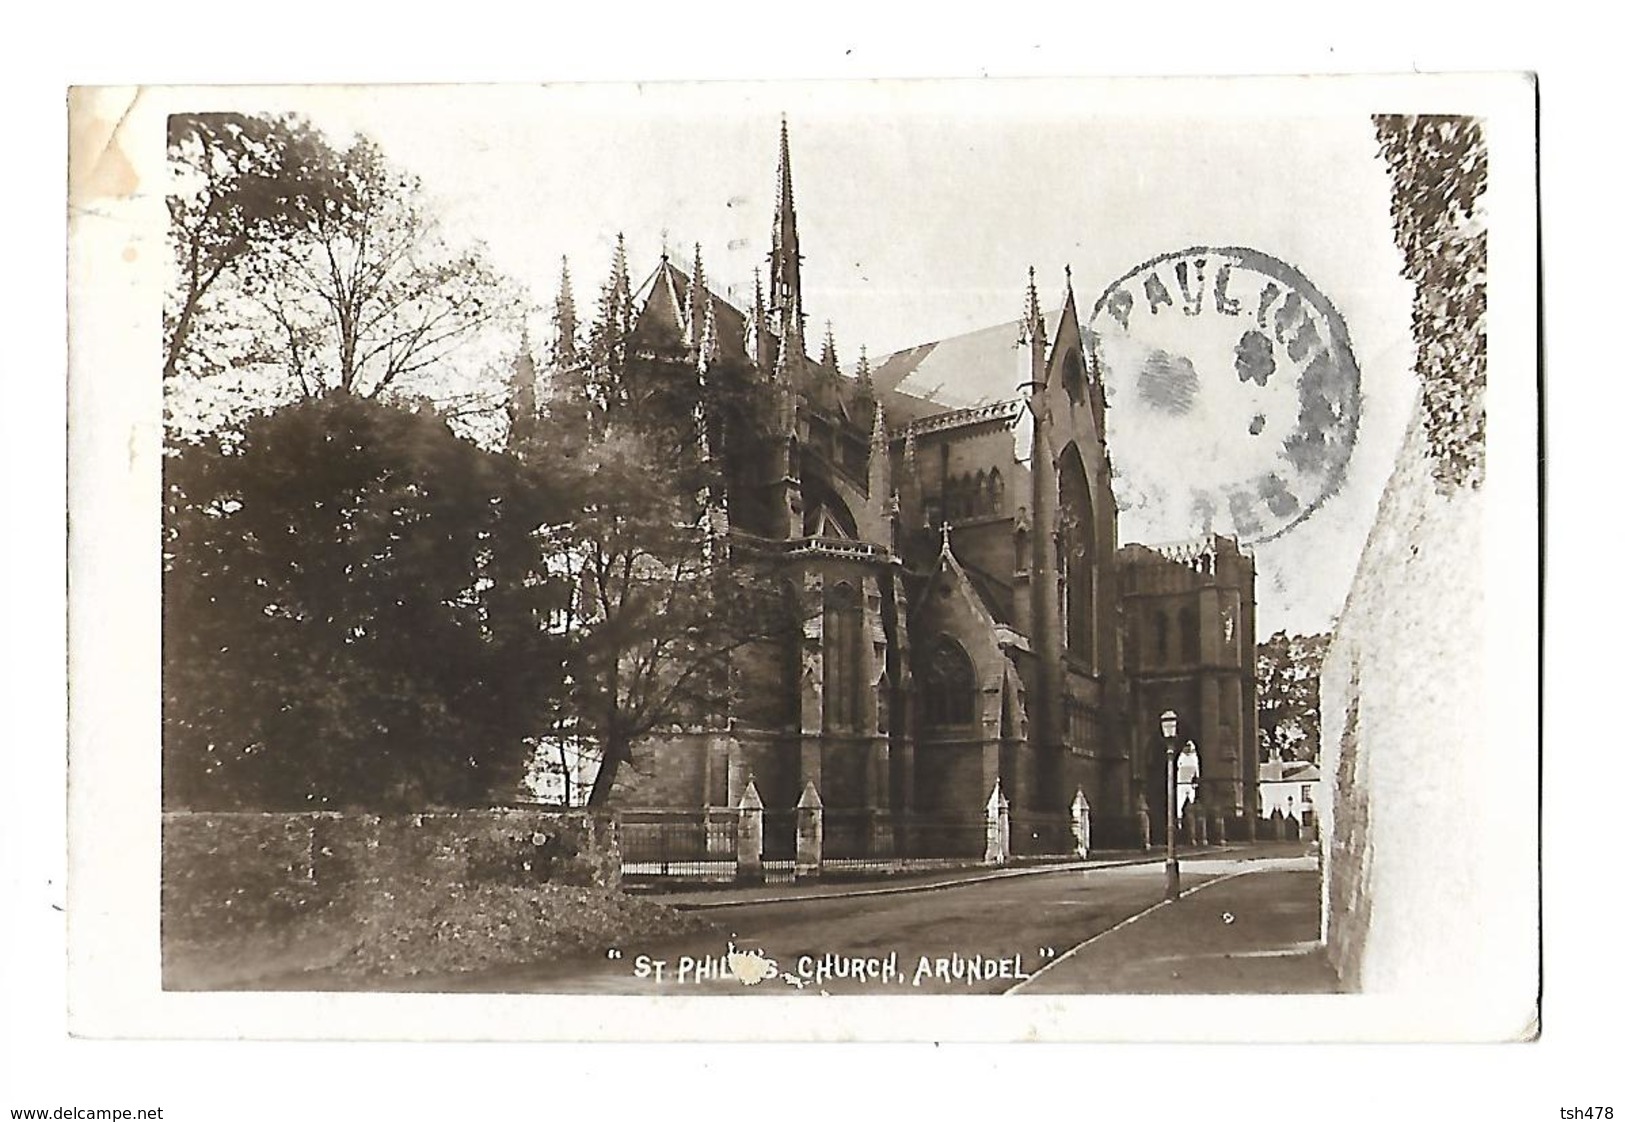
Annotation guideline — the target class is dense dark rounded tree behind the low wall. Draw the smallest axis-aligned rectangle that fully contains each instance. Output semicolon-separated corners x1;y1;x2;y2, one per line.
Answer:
163;394;567;810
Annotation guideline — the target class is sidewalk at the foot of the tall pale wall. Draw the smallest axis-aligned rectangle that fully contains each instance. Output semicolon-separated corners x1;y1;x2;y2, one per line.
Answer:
1011;857;1341;995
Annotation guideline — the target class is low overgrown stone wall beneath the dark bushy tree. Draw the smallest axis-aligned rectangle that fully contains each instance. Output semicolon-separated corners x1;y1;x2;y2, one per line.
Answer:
163;810;621;938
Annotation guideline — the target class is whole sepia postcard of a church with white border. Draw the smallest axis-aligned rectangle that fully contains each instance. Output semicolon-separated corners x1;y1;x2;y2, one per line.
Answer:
68;75;1541;1041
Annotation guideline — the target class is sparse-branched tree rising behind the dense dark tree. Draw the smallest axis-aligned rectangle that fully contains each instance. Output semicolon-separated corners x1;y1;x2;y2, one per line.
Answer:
166;117;520;434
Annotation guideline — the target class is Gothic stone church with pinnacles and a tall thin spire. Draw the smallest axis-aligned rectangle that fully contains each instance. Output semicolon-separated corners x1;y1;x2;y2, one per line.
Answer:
526;124;1258;855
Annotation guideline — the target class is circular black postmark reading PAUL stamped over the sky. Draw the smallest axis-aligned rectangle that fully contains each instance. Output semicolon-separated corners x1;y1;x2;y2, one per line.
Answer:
1087;247;1360;543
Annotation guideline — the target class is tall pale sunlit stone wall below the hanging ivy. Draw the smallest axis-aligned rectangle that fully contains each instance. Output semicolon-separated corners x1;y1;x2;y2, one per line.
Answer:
1321;404;1537;1014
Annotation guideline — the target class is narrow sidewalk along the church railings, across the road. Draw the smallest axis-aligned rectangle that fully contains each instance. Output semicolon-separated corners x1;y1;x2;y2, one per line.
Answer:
632;842;1302;911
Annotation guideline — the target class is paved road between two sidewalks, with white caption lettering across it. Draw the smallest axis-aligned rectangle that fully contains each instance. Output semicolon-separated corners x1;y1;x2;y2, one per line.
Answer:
396;857;1306;997
